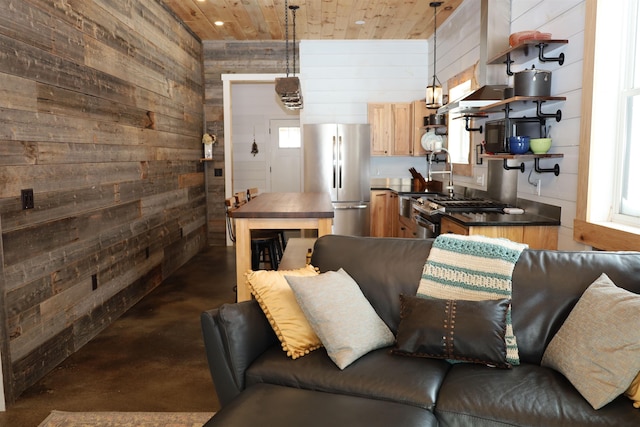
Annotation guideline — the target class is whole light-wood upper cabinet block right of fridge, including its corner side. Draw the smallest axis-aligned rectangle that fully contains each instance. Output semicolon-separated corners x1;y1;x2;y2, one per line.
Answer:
368;101;428;156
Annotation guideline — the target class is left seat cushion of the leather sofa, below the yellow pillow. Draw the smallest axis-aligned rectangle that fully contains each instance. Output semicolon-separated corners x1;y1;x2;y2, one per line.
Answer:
245;347;450;410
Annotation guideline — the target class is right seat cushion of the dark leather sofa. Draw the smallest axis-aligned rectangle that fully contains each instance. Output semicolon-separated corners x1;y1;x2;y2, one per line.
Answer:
435;363;640;427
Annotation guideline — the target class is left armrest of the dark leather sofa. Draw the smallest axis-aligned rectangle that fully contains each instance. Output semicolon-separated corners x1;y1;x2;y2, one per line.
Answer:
200;300;278;406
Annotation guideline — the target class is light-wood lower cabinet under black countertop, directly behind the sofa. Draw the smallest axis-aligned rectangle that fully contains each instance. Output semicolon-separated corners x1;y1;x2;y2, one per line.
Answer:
440;216;558;249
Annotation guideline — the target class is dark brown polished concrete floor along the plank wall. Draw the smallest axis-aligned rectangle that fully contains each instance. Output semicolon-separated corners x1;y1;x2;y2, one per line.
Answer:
0;247;235;427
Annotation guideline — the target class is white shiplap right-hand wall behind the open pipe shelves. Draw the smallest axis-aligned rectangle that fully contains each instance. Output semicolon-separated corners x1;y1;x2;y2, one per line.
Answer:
429;0;585;250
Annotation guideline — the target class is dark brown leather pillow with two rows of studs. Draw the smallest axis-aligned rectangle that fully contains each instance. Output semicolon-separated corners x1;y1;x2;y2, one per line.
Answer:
392;295;511;368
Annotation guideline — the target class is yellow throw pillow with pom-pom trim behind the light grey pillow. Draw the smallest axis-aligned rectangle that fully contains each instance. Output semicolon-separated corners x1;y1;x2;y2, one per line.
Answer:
247;265;322;359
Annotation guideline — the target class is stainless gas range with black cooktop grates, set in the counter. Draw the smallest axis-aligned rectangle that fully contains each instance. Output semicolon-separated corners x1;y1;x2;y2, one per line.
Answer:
412;196;508;239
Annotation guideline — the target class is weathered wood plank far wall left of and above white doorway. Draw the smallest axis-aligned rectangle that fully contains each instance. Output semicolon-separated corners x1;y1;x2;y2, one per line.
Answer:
203;40;290;246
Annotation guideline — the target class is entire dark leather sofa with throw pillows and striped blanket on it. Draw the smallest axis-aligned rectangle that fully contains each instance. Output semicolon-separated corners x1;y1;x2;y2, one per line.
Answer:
201;235;640;427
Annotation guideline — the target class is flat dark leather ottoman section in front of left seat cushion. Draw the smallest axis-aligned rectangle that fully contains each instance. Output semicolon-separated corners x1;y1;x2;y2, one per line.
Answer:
204;384;438;427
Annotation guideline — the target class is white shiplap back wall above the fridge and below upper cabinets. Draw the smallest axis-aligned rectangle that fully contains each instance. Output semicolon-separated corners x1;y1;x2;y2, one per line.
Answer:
300;40;429;178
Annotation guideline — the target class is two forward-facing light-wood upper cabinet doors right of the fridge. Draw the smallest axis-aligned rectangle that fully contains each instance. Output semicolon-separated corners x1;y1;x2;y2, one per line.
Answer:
368;103;413;156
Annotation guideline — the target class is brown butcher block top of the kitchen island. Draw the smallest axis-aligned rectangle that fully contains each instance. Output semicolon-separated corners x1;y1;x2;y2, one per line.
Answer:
232;193;334;219
